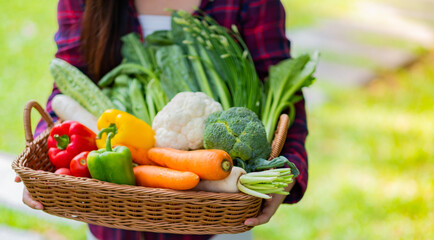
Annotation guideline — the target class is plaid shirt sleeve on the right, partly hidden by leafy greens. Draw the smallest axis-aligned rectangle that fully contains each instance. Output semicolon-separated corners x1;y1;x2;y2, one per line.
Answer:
239;0;308;203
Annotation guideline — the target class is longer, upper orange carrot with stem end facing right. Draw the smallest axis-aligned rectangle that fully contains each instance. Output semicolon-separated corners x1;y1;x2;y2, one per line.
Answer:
148;148;233;180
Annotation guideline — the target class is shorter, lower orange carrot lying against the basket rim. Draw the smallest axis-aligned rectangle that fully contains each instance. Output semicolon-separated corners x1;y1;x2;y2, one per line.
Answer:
133;165;200;190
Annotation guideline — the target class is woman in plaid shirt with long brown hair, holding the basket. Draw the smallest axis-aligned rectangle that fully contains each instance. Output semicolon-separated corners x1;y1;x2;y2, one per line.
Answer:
17;0;307;239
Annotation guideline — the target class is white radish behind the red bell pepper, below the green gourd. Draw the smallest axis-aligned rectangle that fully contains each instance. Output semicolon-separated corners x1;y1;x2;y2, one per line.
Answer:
51;94;98;133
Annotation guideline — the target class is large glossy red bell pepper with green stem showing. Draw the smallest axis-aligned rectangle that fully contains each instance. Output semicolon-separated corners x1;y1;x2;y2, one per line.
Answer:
47;121;98;169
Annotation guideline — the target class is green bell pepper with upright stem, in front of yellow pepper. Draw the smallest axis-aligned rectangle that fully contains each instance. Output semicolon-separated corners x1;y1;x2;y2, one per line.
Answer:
87;133;136;185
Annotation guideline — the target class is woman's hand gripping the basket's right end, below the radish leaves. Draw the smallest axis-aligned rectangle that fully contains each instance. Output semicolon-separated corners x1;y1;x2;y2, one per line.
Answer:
244;181;295;226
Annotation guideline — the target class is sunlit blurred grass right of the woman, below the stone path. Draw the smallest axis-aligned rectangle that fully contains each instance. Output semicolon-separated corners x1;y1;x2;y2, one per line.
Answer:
254;52;434;240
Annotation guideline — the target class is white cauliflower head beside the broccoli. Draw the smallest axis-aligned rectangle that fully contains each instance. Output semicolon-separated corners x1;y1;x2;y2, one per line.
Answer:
152;92;222;150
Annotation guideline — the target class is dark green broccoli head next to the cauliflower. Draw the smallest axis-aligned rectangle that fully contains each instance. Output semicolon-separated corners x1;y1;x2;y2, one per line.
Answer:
203;107;271;161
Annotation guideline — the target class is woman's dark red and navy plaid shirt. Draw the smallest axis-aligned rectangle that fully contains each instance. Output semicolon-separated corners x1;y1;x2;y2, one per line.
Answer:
35;0;308;240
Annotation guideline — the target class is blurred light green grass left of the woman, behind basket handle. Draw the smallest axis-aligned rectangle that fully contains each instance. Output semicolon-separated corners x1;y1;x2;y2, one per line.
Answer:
0;0;57;154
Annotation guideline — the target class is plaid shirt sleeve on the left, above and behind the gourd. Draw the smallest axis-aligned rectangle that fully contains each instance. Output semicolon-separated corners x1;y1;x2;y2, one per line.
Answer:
35;0;85;137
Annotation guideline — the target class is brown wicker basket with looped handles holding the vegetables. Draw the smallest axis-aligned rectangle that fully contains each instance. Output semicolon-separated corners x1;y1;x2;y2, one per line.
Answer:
12;101;288;234
